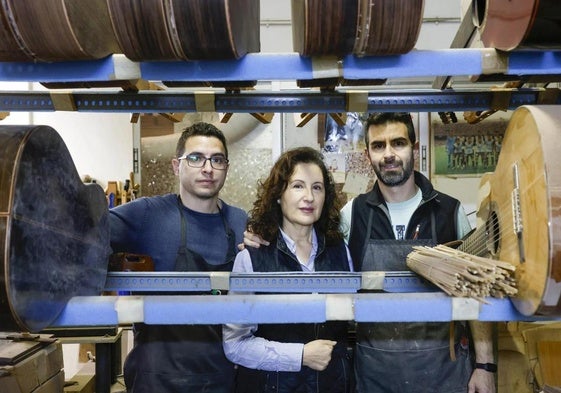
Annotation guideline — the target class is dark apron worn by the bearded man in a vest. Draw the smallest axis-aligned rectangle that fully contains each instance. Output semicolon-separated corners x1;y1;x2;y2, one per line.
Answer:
355;211;472;393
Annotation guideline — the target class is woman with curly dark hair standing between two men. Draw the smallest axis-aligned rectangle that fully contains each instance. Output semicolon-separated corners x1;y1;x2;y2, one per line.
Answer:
223;147;352;393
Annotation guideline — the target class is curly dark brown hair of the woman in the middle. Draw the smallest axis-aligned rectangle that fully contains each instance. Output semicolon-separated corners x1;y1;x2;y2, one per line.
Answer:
247;147;343;244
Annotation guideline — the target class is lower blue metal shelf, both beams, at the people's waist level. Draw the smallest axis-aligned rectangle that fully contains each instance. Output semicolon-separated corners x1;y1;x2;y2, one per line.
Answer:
44;272;557;327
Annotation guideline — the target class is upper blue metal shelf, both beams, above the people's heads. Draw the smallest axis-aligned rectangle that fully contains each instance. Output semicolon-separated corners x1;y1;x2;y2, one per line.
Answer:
0;49;561;113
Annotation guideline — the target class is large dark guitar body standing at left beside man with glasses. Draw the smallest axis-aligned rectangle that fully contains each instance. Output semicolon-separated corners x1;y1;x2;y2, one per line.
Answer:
0;126;110;332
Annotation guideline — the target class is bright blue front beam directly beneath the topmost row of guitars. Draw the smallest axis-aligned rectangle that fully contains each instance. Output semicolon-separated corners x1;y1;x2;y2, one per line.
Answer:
0;48;561;83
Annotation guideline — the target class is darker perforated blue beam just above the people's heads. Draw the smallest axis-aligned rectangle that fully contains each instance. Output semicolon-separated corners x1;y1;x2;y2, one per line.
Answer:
0;88;561;113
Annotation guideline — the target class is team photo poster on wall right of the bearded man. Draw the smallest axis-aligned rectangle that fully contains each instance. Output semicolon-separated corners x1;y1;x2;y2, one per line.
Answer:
431;113;508;176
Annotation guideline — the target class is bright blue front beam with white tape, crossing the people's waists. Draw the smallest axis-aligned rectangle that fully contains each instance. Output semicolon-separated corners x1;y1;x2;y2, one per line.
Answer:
51;292;559;327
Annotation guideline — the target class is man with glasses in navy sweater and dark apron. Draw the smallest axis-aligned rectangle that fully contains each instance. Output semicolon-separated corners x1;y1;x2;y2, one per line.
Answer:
110;122;247;393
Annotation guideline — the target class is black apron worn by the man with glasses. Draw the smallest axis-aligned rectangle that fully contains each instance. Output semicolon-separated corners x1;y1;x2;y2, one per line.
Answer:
124;202;236;393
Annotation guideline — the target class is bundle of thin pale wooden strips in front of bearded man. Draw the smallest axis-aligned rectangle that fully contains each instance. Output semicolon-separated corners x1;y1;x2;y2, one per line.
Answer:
407;245;518;302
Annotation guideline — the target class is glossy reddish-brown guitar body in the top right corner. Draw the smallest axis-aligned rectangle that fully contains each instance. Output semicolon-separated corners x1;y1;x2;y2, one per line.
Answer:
472;0;561;51
